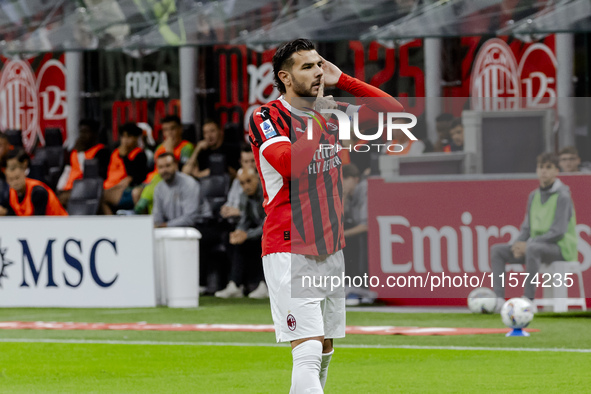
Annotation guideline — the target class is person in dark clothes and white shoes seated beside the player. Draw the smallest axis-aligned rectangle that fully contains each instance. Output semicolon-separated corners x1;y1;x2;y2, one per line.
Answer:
215;167;269;298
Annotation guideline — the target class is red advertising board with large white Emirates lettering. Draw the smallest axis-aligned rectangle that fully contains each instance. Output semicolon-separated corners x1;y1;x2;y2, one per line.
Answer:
368;175;591;305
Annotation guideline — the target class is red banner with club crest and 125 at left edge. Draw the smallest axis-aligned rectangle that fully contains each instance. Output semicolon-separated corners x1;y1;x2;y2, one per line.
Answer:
0;53;68;152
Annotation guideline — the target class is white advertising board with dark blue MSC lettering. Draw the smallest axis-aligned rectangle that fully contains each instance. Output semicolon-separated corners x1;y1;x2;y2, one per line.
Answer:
0;216;156;307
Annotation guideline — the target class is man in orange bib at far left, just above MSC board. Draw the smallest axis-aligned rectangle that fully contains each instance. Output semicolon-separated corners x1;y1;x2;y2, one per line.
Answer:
0;148;68;216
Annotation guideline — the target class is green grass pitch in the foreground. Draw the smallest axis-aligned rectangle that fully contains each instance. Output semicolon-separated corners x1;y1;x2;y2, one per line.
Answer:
0;298;591;393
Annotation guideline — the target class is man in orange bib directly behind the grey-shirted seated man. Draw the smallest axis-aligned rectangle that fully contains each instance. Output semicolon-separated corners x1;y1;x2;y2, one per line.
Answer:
133;115;194;214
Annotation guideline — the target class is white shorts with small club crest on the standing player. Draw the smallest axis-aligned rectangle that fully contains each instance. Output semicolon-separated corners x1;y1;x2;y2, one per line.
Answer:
263;250;345;342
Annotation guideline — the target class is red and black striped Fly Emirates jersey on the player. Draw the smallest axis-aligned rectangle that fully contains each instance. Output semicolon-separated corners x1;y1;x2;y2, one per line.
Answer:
249;74;401;256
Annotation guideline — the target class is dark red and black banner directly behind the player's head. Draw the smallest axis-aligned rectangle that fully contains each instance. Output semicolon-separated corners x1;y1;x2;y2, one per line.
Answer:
213;40;425;135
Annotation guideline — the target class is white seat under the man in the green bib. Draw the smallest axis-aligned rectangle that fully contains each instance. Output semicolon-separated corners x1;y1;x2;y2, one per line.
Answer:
534;261;587;312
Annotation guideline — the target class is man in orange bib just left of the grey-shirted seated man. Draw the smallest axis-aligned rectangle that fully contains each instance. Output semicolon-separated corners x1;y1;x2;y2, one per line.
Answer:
103;123;148;215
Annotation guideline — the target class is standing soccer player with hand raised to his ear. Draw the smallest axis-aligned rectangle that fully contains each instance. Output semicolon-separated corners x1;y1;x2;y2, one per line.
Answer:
249;39;403;393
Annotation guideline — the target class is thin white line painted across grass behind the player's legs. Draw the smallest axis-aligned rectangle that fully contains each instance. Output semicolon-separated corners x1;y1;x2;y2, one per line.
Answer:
0;338;591;353
